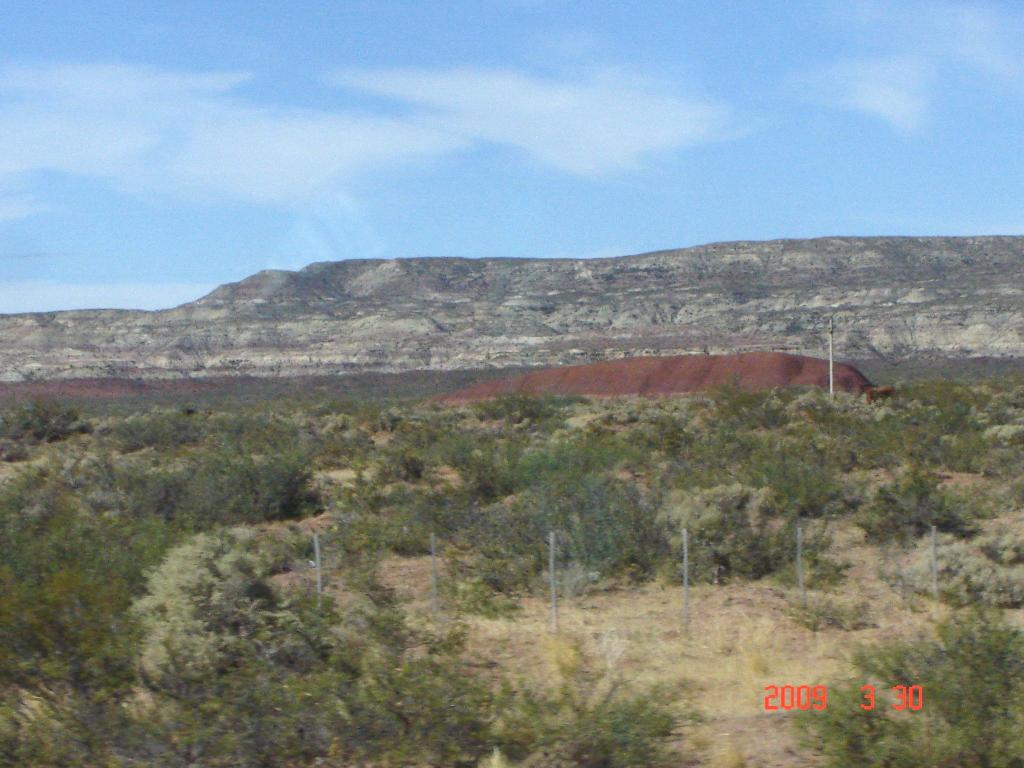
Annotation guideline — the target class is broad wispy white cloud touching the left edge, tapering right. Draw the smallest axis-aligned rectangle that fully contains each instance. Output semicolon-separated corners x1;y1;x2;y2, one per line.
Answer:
0;66;460;204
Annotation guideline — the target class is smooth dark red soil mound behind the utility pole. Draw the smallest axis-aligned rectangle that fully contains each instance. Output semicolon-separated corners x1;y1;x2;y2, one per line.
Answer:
436;352;870;404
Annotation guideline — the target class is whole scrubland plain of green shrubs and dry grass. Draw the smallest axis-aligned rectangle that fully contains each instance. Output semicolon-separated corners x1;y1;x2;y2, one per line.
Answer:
0;378;1024;768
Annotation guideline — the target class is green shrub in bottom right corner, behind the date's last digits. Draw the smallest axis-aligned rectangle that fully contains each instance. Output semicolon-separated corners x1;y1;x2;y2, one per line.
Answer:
800;612;1024;768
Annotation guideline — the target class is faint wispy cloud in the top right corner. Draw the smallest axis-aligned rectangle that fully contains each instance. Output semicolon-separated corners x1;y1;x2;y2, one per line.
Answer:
792;1;1024;133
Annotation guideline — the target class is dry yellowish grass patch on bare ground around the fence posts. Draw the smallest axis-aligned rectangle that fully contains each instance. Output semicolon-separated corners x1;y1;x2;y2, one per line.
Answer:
370;520;943;768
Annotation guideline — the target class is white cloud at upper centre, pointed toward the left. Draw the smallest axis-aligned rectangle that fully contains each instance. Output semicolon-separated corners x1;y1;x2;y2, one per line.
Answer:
335;68;732;175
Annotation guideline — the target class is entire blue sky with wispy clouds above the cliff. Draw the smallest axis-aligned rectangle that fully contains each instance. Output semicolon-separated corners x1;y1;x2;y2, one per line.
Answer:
0;0;1024;312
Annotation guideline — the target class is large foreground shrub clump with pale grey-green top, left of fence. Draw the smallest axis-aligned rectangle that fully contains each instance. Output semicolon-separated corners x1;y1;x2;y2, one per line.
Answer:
133;528;492;766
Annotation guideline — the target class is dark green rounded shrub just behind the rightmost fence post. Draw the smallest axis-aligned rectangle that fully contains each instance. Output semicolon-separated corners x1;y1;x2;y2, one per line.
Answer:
854;467;976;544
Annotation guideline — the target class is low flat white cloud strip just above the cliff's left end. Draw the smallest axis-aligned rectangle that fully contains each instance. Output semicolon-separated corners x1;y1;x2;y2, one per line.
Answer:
0;281;216;314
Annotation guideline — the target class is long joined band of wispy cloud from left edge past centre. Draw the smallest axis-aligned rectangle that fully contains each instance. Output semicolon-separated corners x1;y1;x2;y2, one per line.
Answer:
0;65;728;219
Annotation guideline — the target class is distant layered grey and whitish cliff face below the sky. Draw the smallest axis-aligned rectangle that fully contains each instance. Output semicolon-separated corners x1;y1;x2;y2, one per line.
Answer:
0;238;1024;381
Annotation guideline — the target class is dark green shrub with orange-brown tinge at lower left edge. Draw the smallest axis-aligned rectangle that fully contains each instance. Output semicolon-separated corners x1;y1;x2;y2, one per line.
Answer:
0;467;169;768
